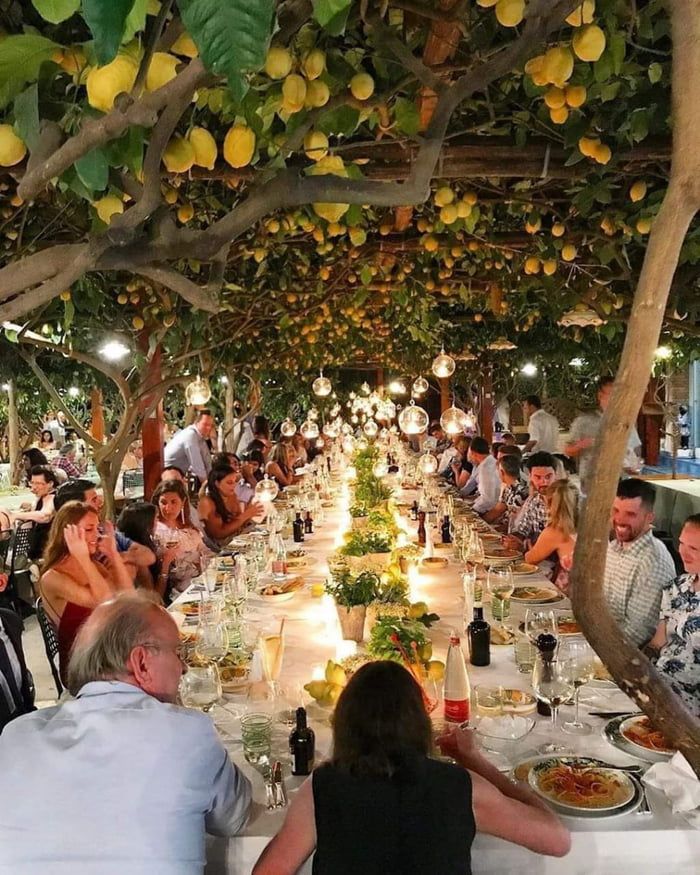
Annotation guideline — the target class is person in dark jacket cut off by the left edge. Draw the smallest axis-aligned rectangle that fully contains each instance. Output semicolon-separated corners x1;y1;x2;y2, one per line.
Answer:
0;574;34;732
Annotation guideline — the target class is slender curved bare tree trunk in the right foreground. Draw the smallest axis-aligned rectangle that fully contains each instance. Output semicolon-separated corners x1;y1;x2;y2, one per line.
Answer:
572;0;700;775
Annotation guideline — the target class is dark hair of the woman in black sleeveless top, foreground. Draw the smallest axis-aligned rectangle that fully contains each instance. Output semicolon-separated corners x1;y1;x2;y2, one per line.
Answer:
333;661;432;778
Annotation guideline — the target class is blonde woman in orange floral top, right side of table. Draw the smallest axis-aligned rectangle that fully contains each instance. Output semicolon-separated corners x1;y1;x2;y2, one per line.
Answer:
525;480;579;590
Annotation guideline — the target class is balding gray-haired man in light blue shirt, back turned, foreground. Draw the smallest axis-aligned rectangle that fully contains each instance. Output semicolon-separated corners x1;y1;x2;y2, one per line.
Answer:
0;592;251;875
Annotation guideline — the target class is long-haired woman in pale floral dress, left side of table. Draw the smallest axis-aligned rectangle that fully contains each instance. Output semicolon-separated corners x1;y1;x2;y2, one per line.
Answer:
152;480;213;595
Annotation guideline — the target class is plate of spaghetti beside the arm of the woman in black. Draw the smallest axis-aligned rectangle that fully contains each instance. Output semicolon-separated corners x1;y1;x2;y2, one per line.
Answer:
528;757;636;814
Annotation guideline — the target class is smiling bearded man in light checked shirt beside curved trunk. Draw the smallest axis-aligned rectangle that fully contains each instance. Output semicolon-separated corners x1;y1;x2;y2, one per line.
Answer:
603;478;676;647
